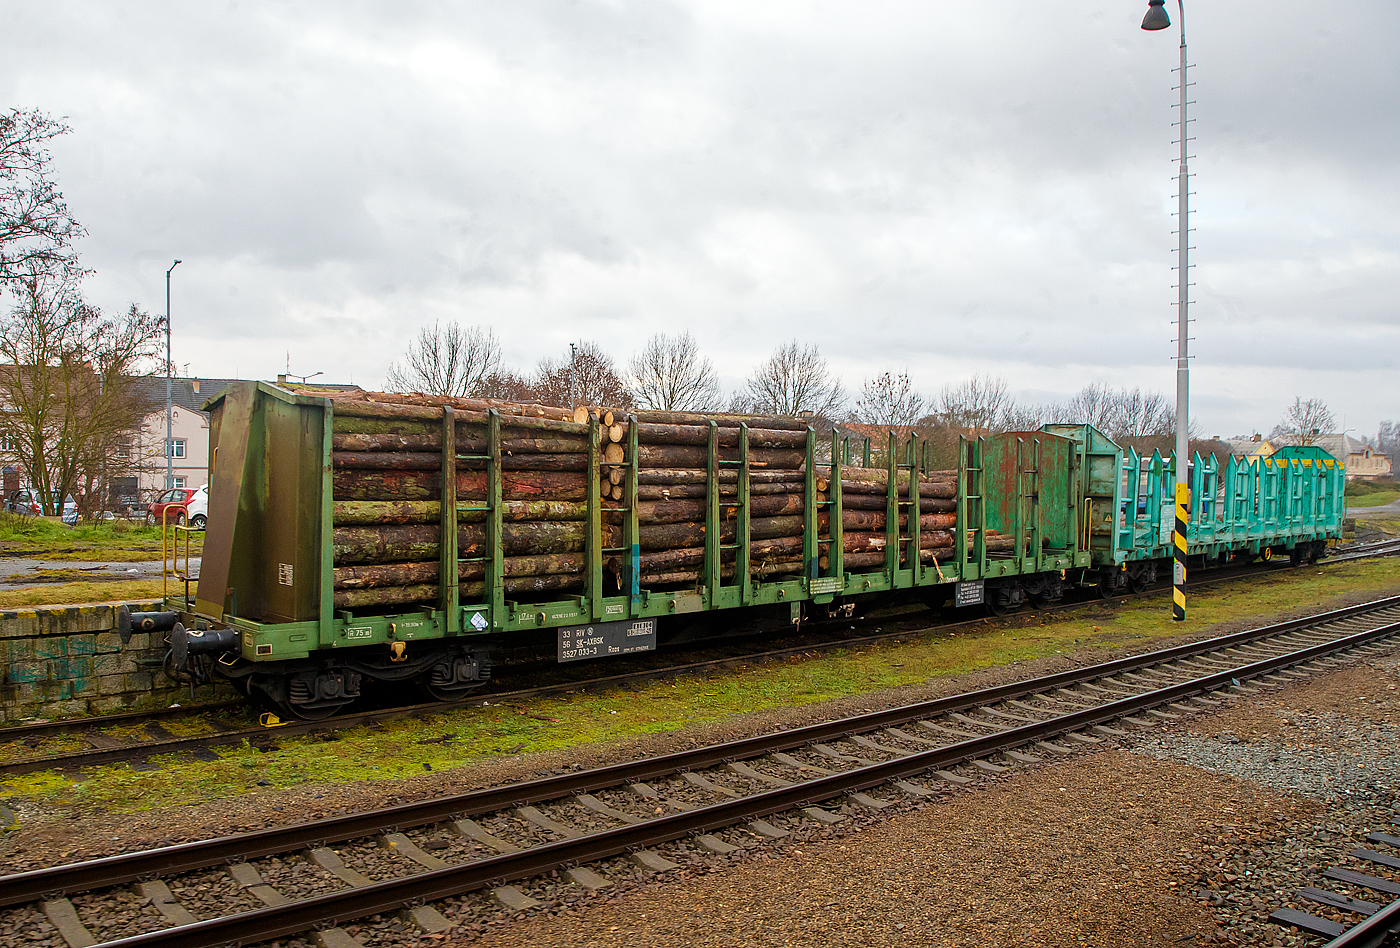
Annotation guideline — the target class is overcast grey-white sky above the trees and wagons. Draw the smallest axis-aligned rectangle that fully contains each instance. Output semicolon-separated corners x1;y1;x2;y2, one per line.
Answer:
0;0;1400;435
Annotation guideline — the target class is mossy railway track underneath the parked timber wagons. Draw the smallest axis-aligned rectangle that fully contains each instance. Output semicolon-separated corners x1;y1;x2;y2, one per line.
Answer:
0;553;1332;776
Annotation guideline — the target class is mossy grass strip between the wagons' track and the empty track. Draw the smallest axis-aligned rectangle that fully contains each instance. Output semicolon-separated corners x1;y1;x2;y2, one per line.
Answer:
0;557;1400;816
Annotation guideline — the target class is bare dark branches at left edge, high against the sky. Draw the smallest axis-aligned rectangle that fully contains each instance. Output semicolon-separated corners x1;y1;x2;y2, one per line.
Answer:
0;108;83;293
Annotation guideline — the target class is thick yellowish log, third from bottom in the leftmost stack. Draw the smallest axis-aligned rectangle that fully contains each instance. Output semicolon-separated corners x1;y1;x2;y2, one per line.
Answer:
332;521;585;566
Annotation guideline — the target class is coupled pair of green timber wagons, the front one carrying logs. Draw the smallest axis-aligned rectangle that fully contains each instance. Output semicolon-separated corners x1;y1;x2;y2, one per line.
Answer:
134;384;1341;717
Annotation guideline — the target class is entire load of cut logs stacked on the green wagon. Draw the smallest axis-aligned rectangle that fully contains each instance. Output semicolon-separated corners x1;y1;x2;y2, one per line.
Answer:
323;392;1011;609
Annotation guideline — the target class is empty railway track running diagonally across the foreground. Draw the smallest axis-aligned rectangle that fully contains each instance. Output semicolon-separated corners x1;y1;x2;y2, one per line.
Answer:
0;597;1400;948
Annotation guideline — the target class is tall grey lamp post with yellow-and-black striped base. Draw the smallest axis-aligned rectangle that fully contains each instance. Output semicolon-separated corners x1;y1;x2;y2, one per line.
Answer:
1142;0;1191;622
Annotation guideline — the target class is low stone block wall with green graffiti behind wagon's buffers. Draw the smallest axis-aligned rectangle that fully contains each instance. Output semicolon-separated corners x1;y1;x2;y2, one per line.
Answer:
0;602;231;724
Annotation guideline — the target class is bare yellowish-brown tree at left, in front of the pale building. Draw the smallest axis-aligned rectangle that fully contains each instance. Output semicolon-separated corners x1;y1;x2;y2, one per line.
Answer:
0;272;164;515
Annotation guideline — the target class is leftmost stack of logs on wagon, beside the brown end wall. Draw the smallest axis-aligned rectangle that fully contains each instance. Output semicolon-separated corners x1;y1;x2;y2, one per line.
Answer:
332;392;595;609
